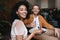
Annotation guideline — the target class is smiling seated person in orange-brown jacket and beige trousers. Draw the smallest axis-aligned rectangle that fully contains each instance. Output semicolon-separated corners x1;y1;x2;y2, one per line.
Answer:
24;5;59;40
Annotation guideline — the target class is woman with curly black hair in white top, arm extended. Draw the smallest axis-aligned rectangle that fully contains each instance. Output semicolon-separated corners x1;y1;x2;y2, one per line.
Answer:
11;1;41;40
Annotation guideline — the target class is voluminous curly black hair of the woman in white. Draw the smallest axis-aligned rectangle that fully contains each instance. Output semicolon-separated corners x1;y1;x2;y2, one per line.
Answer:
11;1;29;23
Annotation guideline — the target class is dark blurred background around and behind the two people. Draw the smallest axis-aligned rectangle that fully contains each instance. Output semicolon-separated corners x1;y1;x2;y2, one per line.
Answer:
0;0;60;40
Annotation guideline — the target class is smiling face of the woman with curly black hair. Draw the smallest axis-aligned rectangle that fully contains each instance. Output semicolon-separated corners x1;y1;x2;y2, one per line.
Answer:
16;5;27;18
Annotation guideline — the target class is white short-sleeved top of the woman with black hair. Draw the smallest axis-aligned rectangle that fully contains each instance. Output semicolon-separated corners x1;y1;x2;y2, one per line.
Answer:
11;19;28;40
